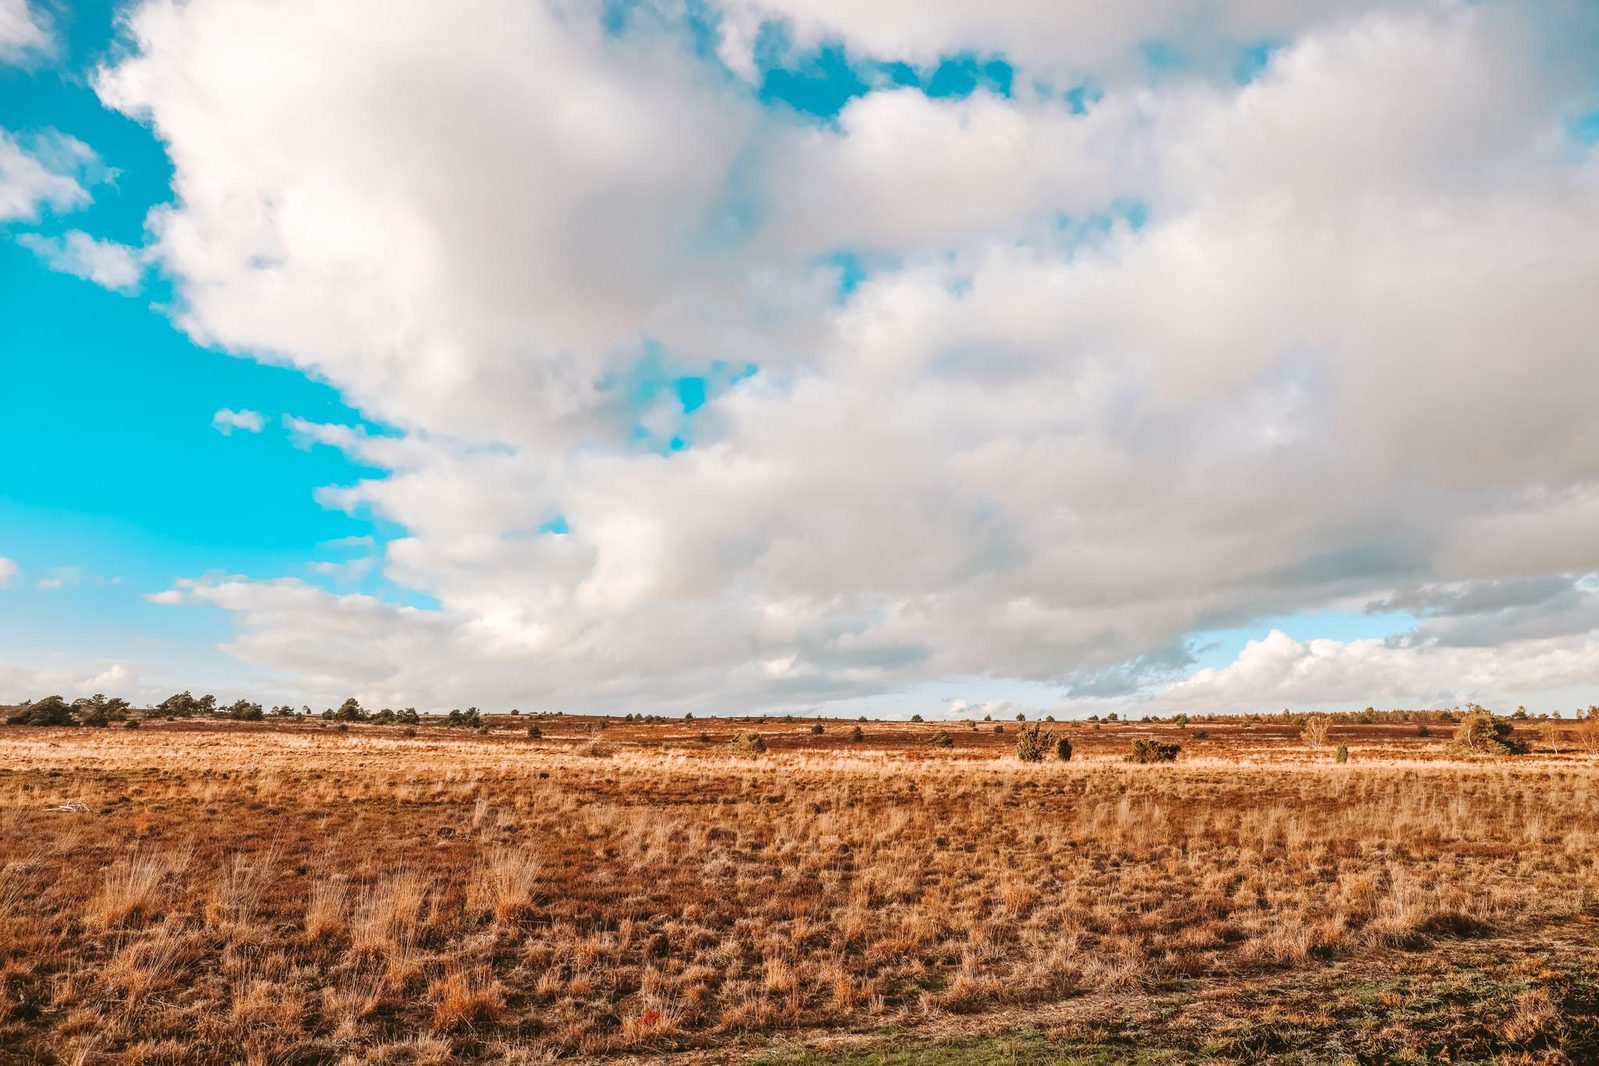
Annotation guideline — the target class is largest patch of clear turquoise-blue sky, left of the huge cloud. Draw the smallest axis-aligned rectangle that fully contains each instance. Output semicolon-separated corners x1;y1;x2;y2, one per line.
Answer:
0;0;430;657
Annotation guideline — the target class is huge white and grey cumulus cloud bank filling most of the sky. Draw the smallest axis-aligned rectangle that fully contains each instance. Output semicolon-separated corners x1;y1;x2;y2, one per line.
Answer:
112;0;1599;710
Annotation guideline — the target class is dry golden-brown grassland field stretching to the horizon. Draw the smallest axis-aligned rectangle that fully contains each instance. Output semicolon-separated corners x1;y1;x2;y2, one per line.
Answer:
0;714;1599;1066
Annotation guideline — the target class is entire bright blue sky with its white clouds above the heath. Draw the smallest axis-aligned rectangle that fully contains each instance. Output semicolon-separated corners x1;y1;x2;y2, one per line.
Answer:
0;0;1599;714
